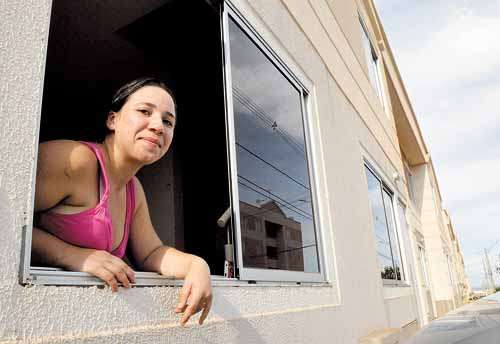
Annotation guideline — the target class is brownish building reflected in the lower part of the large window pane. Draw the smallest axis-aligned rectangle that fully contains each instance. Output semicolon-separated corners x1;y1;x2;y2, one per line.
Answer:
240;201;304;271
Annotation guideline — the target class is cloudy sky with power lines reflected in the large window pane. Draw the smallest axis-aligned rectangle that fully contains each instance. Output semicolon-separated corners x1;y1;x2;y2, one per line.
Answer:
229;20;319;272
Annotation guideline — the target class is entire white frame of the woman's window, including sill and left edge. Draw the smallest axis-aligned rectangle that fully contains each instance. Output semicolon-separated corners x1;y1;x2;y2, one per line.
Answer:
19;0;331;287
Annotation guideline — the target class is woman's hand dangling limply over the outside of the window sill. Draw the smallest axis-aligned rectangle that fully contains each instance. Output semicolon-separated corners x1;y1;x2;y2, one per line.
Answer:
175;256;212;326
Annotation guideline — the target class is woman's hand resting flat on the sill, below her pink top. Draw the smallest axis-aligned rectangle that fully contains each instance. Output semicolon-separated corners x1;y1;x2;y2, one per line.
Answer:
65;247;135;292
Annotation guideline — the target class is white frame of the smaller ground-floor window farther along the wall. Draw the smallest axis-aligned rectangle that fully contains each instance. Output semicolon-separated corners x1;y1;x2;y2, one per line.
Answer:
362;159;410;287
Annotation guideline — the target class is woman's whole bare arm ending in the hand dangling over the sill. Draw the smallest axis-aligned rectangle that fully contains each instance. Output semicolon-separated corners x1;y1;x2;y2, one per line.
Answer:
130;178;212;325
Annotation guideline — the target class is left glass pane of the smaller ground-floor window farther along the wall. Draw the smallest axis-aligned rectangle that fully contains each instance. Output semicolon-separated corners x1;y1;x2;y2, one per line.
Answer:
366;168;395;279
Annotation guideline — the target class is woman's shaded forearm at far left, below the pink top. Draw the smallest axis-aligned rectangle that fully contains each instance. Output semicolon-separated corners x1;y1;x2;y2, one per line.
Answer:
31;227;78;270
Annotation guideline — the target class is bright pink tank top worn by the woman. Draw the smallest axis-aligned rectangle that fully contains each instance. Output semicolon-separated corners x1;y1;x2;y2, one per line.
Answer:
39;142;135;258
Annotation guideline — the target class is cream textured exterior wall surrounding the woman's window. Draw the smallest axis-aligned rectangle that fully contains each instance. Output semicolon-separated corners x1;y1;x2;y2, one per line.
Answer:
0;0;442;344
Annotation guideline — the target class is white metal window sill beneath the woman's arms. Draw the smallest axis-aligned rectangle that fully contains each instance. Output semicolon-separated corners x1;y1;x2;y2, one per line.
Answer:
27;267;332;287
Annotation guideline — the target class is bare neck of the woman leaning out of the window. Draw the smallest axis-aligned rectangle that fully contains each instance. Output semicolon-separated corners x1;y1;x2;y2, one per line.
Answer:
102;135;142;190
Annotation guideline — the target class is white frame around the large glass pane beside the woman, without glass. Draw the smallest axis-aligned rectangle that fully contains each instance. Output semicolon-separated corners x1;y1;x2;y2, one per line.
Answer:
222;0;327;283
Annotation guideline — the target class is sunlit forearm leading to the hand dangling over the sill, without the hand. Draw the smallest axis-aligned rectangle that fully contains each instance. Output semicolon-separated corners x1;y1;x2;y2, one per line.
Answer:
144;246;210;279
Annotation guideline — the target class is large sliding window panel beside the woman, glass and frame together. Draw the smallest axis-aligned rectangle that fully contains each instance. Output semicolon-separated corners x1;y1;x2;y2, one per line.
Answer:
224;10;324;282
